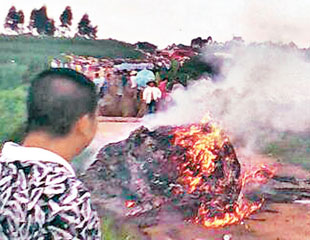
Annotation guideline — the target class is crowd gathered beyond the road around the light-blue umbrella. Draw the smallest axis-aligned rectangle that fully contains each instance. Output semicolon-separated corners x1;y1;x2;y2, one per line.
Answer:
50;56;182;117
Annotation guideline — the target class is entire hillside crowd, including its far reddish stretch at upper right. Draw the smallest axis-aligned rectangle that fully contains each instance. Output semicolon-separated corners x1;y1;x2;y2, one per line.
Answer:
50;44;197;117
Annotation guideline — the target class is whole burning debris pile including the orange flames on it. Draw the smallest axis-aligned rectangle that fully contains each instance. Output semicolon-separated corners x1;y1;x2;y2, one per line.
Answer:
83;121;268;227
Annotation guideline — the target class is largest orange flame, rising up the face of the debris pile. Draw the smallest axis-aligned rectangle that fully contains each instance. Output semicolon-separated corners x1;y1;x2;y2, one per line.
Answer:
173;115;228;193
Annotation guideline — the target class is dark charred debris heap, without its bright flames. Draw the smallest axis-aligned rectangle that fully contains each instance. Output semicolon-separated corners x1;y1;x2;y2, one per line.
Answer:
82;124;241;227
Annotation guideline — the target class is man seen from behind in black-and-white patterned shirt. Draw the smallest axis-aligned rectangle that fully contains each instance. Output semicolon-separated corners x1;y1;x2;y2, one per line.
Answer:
0;68;100;239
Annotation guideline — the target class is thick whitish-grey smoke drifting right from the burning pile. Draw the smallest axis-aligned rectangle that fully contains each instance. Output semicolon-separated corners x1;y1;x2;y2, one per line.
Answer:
145;44;310;150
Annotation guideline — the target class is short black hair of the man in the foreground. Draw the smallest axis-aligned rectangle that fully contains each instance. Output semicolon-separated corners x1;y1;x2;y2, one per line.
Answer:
26;68;98;137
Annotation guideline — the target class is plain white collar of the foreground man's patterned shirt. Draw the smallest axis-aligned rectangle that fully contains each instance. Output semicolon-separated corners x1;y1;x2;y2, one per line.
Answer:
0;142;75;175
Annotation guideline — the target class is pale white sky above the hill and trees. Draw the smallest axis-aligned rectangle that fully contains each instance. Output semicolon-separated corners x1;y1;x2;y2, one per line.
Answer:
0;0;310;48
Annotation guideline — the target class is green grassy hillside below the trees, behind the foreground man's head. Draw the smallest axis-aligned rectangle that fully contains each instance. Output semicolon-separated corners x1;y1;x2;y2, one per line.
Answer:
0;35;143;144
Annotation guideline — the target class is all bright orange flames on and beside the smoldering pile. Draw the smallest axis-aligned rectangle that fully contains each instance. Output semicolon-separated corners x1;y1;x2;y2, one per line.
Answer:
173;114;274;228
